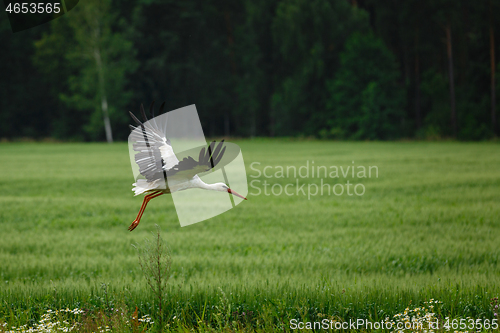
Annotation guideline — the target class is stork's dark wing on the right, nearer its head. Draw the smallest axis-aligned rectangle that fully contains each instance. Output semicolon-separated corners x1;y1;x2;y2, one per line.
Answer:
167;140;226;179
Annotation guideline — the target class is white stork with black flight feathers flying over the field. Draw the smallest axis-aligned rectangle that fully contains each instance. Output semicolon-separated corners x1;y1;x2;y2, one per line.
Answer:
128;102;247;231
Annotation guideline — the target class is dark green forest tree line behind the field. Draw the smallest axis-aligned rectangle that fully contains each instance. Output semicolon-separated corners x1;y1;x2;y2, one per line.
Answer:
0;0;500;141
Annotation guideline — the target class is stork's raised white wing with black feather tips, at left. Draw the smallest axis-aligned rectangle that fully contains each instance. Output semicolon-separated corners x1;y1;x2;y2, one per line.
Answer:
130;102;179;182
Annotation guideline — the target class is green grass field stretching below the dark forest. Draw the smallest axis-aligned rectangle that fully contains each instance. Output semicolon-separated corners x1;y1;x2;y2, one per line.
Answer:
0;139;500;332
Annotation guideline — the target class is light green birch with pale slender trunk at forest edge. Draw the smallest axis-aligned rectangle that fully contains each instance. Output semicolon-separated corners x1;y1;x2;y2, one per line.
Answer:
36;0;137;142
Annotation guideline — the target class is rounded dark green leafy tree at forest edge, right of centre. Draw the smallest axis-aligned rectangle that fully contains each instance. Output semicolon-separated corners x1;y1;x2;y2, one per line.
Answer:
327;34;404;140
